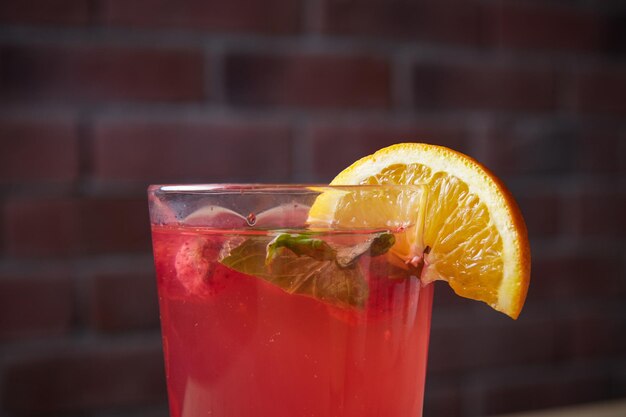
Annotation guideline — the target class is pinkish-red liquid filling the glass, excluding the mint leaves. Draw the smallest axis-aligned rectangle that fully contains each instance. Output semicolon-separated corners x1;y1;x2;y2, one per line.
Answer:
152;225;433;417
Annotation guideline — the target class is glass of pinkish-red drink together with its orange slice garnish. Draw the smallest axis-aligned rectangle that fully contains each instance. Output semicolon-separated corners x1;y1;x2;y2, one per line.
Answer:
148;144;530;417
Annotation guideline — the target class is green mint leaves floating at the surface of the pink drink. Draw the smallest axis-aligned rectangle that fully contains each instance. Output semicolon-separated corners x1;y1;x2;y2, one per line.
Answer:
221;232;395;308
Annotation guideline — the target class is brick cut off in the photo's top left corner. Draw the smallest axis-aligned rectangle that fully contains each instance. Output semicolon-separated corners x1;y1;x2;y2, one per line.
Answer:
0;0;90;26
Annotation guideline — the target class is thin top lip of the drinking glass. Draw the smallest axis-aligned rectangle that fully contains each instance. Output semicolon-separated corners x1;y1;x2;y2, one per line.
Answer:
148;183;426;195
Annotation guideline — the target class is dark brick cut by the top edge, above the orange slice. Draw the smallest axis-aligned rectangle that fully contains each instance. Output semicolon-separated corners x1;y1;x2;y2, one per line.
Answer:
323;0;481;44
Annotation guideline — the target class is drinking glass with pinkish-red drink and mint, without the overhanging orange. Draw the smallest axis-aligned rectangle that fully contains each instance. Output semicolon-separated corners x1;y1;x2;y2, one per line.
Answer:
148;184;433;417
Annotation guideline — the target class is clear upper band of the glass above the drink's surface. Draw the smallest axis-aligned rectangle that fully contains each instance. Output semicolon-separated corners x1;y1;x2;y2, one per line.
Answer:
148;183;428;230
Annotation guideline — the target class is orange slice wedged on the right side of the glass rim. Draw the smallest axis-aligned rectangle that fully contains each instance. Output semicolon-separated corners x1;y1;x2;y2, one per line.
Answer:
309;143;530;319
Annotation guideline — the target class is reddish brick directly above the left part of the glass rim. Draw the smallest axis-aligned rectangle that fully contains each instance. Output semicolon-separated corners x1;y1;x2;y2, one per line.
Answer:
94;120;291;182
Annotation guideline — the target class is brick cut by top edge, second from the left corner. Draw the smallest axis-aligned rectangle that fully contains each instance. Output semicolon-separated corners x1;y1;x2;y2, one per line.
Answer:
101;0;302;34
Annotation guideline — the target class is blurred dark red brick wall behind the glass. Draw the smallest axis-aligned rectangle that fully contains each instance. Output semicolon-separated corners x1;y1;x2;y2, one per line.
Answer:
0;0;626;417
